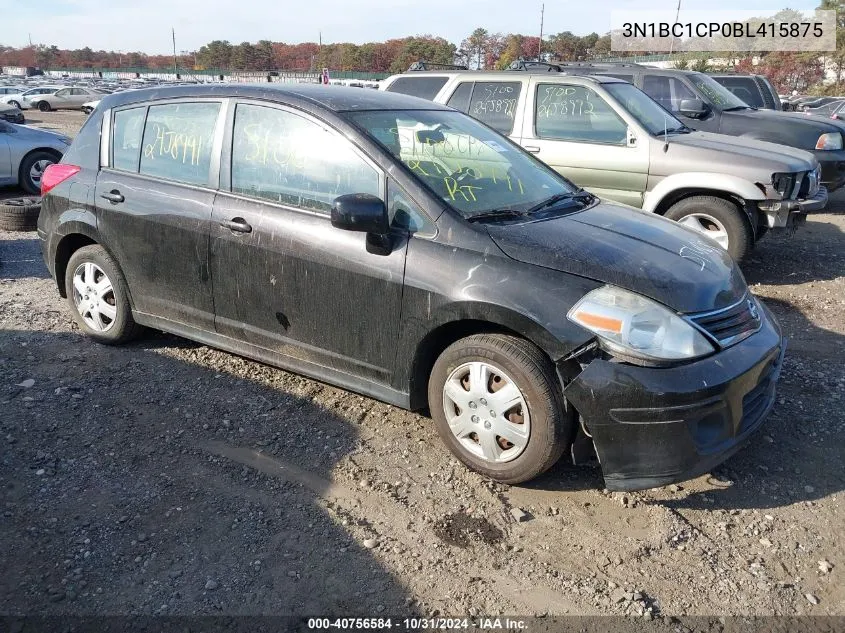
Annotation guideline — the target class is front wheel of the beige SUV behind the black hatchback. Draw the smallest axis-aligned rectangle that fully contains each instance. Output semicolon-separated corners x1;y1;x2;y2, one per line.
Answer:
665;196;754;262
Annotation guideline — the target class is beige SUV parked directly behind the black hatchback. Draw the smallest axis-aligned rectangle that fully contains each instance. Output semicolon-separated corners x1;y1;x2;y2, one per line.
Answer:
381;71;827;261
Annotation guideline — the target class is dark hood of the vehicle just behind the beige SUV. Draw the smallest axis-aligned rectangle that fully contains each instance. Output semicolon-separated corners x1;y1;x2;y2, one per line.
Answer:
719;110;845;151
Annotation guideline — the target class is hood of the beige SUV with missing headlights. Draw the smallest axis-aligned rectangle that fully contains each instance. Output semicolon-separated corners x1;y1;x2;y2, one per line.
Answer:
651;132;818;177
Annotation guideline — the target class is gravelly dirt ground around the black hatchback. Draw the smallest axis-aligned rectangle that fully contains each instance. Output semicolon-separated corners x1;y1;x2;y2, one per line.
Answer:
0;113;845;623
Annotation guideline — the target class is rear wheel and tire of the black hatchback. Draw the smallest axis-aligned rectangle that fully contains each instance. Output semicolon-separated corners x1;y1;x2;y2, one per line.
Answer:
65;244;143;345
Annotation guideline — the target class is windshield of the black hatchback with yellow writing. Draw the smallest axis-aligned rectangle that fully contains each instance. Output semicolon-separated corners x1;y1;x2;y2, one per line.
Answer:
348;110;578;218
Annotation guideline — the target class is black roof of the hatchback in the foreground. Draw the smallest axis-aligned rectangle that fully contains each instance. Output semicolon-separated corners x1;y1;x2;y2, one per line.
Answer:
95;83;448;112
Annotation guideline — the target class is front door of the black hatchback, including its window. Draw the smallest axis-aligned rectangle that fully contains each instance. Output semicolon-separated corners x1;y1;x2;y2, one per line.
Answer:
211;102;407;382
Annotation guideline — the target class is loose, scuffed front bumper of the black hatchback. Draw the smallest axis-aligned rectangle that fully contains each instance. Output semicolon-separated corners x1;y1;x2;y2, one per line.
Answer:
564;308;786;490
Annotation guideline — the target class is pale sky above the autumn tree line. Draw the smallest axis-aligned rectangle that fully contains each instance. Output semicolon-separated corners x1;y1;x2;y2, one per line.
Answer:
0;0;818;54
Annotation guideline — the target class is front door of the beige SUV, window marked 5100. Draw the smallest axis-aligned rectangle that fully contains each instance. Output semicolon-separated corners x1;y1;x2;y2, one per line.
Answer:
521;79;649;207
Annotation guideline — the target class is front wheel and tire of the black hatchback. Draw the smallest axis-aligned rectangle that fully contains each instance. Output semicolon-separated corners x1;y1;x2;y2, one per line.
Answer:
428;334;576;484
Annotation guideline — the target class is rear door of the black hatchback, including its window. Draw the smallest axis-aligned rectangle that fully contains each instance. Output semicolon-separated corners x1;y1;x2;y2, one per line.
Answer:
96;99;227;331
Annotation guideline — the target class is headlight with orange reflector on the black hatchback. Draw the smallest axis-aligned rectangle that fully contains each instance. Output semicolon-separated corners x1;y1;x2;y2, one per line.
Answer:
566;286;714;361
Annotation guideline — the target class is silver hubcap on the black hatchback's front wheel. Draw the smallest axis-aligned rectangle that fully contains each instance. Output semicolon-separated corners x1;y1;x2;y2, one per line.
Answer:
443;361;531;463
